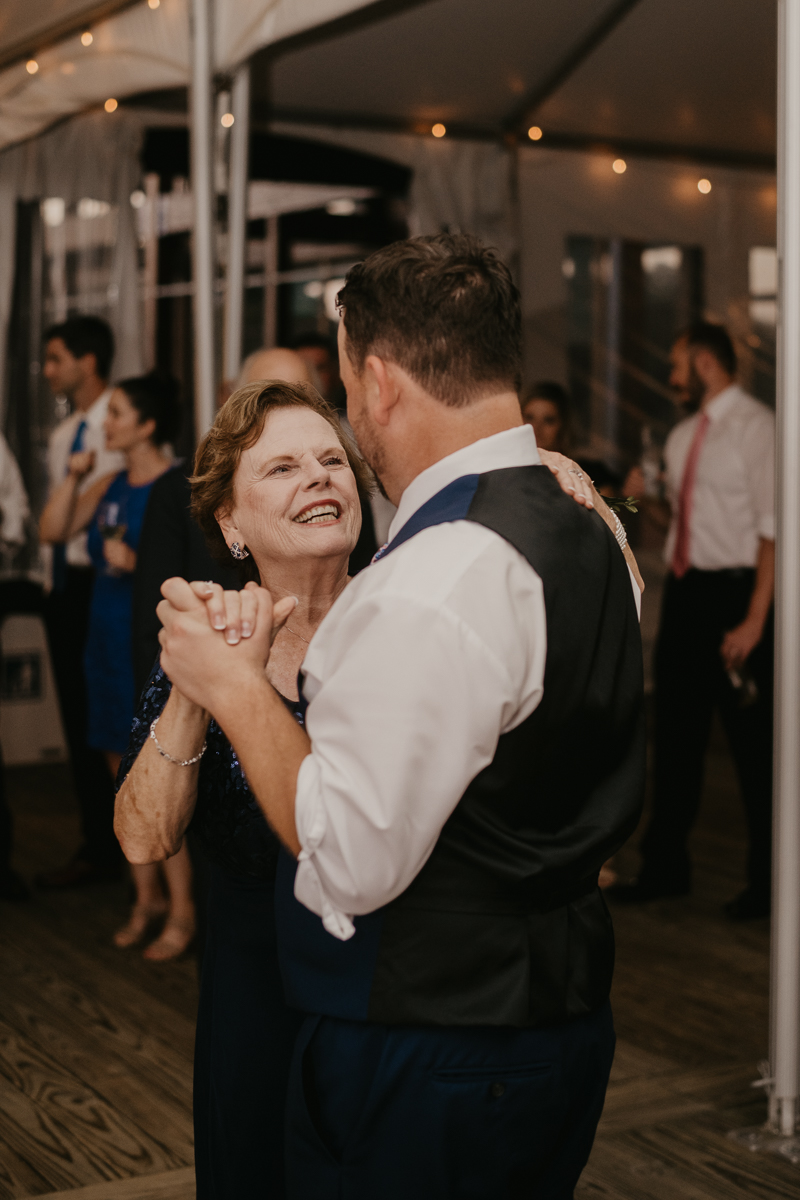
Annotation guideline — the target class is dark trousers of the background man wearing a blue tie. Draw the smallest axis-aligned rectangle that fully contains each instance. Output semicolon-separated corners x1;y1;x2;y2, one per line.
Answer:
44;568;121;870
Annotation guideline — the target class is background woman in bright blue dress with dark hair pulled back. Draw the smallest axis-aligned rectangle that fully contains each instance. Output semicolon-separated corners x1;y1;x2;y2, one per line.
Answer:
42;374;194;961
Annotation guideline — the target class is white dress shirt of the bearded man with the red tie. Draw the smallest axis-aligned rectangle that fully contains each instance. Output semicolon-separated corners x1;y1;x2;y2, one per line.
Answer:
664;384;775;571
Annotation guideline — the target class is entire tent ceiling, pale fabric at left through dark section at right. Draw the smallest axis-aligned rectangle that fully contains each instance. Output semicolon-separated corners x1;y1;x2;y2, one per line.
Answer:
0;0;776;166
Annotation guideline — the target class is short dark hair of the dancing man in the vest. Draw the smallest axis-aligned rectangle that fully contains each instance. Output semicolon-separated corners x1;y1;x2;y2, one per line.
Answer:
337;233;522;407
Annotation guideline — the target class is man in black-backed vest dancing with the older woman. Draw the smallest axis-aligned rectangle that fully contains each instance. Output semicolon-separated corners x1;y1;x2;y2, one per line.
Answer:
160;235;644;1200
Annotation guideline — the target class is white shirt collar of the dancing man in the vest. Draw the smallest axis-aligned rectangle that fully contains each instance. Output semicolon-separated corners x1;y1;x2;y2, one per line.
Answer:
389;425;542;541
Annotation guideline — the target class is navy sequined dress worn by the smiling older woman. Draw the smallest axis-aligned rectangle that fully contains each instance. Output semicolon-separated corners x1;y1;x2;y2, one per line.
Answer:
119;667;305;1200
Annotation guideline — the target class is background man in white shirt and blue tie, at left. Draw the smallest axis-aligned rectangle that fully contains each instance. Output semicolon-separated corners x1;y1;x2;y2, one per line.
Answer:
36;316;125;888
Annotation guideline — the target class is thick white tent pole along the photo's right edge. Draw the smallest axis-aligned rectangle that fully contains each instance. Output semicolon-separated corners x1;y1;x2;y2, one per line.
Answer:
770;0;800;1135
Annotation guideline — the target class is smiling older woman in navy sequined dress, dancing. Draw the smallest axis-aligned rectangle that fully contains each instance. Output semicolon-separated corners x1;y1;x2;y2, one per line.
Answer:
115;383;368;1200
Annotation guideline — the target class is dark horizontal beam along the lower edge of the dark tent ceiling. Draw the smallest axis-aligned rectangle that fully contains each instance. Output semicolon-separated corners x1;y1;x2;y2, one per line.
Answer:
268;104;776;172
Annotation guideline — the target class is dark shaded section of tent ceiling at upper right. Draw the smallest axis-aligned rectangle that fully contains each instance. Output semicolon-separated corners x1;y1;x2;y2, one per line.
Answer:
262;0;776;164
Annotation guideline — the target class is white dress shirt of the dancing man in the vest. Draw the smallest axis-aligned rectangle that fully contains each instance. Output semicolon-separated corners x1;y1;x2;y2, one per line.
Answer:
295;425;638;940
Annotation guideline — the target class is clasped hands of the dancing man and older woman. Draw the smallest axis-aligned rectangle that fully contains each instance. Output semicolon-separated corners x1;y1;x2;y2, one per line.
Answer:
156;578;297;716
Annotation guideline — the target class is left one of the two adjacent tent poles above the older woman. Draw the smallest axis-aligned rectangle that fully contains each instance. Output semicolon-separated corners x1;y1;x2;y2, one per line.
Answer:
190;0;216;440
